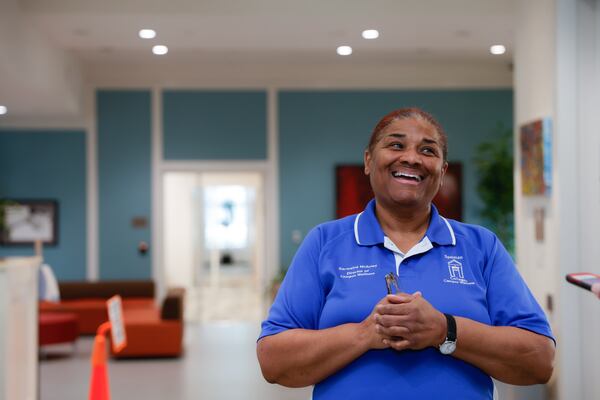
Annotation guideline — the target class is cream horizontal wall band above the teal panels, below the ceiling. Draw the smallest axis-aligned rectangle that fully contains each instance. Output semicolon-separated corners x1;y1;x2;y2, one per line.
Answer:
83;53;512;89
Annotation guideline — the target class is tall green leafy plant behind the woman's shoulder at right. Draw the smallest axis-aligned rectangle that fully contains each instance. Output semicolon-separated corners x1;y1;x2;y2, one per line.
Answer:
473;123;514;254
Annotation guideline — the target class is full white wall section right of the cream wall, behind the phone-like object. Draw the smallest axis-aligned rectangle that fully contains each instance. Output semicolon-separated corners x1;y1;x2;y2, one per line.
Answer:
556;0;600;399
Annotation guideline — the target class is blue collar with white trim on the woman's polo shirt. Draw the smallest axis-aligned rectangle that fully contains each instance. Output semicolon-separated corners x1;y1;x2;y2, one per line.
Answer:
354;199;456;246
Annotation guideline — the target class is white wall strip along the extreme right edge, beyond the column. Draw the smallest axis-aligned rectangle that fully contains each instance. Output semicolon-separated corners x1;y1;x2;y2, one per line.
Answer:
576;1;600;399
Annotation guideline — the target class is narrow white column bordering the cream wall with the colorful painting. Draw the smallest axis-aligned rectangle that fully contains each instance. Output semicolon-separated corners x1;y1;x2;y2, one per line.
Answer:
555;0;583;399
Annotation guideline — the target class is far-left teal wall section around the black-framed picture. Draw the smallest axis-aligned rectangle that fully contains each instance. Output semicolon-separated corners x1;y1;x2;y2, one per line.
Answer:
0;130;87;280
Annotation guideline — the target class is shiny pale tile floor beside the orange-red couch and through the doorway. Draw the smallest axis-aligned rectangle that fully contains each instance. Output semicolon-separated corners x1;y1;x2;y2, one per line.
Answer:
40;276;312;400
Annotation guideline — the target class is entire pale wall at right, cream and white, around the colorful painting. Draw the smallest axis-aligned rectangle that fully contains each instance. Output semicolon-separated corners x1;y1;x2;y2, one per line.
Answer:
513;0;600;399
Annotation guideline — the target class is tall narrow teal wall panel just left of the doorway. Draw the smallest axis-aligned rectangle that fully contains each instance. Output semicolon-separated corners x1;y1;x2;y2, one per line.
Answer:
96;90;152;279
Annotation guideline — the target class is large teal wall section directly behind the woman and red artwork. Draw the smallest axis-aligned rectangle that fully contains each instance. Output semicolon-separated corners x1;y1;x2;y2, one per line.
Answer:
279;90;513;266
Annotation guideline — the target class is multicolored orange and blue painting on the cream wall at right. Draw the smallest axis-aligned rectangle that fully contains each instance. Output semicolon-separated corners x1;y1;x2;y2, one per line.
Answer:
520;118;552;196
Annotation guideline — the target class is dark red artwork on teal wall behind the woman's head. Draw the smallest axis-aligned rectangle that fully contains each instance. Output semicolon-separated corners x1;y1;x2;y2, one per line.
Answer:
335;162;462;221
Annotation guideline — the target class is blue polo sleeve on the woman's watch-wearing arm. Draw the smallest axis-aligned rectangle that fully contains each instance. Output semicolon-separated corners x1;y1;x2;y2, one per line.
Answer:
486;234;556;342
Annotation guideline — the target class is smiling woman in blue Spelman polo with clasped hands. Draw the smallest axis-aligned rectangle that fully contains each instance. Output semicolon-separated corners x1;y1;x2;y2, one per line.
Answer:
257;108;554;400
